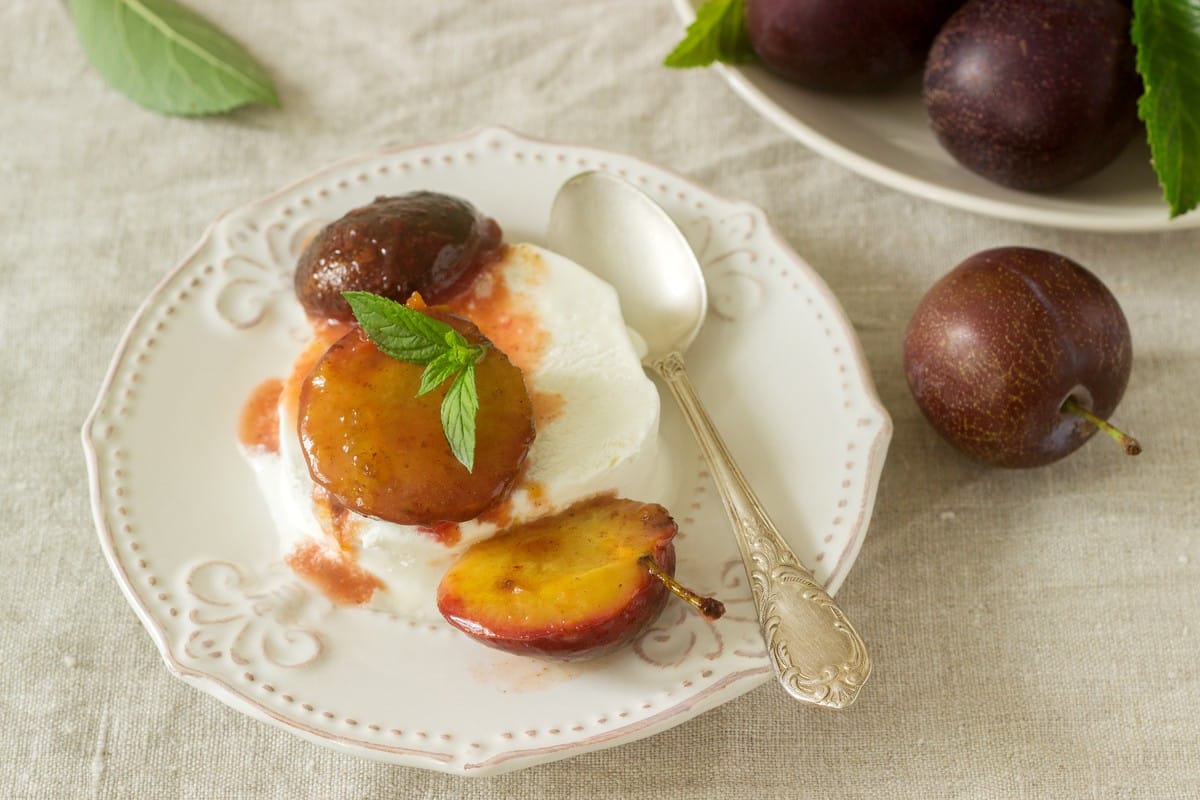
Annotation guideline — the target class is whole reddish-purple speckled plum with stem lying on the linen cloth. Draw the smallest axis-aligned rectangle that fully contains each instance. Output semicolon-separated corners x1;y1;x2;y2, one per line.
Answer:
904;247;1133;468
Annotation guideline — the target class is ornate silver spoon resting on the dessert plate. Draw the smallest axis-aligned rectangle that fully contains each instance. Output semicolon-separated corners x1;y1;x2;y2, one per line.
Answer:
547;172;871;709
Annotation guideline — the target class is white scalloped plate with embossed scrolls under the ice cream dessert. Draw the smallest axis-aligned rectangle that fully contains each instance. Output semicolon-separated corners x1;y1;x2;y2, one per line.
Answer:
83;128;892;775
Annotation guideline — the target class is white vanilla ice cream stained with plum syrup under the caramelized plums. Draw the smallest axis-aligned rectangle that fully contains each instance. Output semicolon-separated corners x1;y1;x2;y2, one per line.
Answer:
247;245;672;621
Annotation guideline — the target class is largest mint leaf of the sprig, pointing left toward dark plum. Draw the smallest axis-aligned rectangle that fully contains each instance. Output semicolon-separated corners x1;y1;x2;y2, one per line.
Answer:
342;291;470;363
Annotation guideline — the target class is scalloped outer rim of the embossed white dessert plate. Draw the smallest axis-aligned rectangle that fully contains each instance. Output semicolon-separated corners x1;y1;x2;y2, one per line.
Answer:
80;125;893;775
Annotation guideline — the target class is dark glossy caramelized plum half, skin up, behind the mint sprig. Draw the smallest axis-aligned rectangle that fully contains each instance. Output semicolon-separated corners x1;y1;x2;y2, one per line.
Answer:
304;192;502;321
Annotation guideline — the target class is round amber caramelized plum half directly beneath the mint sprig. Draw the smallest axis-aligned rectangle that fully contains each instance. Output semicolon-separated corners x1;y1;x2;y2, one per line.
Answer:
299;314;534;525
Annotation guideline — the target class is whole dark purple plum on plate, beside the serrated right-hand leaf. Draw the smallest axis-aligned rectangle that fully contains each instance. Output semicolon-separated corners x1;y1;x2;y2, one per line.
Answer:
924;0;1141;192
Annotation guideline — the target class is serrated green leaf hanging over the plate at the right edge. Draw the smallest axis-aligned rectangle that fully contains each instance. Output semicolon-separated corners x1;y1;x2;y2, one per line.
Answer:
1133;0;1200;217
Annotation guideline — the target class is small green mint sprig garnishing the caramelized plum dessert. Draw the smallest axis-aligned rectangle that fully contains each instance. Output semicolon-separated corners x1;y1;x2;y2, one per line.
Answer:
342;291;487;473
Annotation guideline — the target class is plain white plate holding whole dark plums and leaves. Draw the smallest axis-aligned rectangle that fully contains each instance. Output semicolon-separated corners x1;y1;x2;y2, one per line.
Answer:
672;0;1200;233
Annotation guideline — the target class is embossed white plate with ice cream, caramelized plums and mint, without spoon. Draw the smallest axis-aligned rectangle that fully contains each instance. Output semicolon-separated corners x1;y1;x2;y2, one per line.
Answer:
83;128;890;775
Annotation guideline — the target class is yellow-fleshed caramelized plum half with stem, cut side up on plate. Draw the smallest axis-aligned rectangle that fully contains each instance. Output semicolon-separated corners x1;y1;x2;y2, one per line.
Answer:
438;497;677;658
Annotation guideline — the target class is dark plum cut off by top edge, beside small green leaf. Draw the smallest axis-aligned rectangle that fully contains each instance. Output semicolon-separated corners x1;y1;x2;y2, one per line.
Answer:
745;0;962;91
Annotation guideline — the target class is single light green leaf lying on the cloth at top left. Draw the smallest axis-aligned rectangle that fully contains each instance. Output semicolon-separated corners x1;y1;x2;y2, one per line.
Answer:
68;0;280;115
